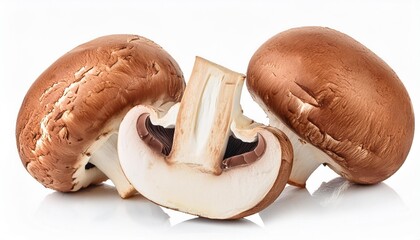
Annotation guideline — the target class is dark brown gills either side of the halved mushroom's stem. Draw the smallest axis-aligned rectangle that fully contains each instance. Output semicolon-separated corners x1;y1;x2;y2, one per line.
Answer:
136;113;265;170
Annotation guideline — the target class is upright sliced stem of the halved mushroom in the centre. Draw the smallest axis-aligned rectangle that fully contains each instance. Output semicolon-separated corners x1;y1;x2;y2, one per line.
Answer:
168;57;245;175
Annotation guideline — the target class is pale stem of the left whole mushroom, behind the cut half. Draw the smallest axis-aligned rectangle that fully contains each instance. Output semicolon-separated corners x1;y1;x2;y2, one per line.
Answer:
89;134;136;198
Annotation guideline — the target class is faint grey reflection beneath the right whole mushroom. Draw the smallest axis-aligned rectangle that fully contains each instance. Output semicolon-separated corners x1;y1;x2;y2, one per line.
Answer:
260;177;406;221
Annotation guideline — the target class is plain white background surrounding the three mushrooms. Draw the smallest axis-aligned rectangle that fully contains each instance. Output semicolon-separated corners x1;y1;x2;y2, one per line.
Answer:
0;0;420;239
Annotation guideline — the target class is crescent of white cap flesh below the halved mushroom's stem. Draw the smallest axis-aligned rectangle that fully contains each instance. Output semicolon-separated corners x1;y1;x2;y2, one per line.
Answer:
118;106;281;219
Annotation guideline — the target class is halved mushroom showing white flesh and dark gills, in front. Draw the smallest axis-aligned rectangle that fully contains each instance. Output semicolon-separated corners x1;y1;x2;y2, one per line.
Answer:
118;58;293;219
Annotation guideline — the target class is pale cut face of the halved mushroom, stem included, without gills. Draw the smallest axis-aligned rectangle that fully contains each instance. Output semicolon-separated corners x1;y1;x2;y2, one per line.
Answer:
118;58;282;219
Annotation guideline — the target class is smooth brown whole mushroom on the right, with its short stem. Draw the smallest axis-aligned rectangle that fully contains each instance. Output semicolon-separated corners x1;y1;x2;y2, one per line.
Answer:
247;27;414;187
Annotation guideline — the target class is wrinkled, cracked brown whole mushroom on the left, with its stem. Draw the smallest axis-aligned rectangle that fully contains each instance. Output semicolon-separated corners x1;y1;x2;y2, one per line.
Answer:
16;35;185;198
